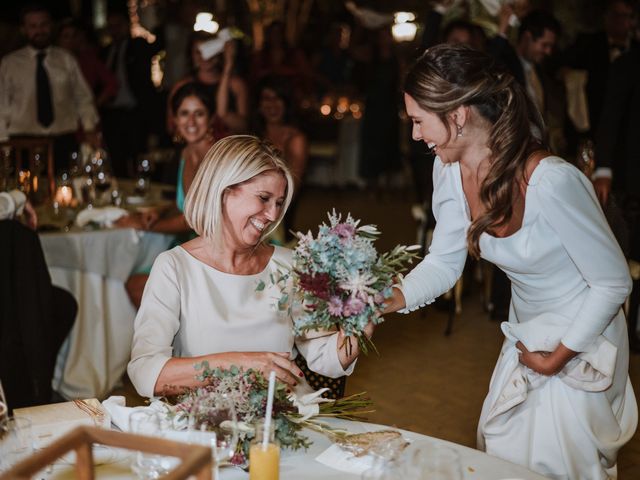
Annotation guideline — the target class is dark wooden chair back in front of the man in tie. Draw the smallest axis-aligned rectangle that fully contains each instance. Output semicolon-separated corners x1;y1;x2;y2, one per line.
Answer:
0;137;56;201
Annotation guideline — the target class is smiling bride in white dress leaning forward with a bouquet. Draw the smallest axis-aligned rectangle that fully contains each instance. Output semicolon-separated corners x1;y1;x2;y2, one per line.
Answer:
388;45;637;479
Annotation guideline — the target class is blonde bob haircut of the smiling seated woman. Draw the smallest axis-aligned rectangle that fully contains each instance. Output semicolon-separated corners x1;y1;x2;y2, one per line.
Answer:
184;135;293;241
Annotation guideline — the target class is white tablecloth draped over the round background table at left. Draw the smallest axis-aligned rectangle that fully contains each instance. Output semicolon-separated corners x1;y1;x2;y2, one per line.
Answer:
40;229;173;399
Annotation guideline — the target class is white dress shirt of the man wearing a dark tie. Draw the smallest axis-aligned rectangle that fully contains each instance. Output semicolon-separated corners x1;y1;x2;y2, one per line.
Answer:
0;46;99;141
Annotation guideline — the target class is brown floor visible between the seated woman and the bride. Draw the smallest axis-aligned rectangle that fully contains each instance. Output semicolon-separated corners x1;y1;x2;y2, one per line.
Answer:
116;186;640;480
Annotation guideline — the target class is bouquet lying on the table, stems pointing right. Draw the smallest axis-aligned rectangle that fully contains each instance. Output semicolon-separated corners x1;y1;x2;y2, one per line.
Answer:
170;362;373;465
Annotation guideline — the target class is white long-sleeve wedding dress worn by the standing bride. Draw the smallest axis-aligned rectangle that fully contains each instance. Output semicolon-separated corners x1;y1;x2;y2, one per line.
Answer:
401;156;637;479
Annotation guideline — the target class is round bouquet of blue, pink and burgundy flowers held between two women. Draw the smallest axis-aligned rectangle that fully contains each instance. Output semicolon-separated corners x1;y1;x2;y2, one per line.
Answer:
258;210;420;353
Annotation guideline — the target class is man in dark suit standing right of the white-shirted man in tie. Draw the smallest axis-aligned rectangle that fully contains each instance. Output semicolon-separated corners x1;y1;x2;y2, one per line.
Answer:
101;10;162;176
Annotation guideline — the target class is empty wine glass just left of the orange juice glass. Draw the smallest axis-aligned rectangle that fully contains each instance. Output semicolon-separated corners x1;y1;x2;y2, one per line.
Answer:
189;393;238;479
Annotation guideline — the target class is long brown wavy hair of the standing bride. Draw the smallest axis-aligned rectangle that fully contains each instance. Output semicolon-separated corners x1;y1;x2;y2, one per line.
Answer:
404;44;547;258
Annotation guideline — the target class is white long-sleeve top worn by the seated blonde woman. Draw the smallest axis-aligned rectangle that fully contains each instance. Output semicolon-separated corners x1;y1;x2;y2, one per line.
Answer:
127;246;354;397
